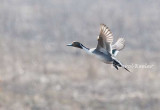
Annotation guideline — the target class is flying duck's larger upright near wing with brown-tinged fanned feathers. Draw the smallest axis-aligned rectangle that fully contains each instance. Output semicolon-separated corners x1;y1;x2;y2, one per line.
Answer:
96;24;113;54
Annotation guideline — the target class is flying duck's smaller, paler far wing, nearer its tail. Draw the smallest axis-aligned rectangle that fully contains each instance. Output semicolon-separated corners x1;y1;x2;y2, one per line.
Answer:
112;38;125;56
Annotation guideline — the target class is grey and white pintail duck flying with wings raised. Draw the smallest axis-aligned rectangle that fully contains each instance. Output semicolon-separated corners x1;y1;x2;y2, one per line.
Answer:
67;24;130;72
